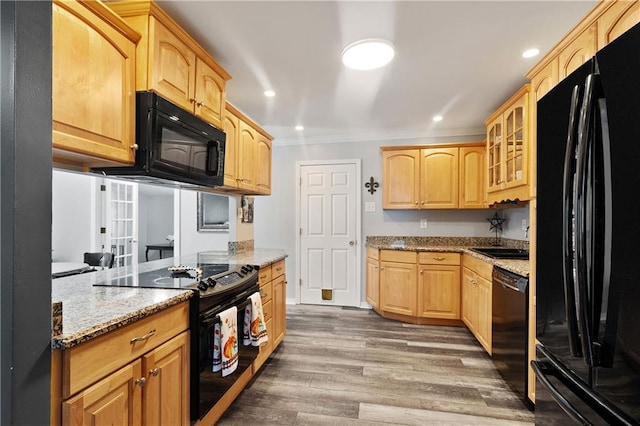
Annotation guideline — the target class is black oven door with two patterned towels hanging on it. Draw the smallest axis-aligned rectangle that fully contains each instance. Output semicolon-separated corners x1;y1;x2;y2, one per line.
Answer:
191;285;259;420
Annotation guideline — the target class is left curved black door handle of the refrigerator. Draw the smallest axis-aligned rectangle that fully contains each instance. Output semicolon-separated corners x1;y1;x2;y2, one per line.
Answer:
562;85;582;356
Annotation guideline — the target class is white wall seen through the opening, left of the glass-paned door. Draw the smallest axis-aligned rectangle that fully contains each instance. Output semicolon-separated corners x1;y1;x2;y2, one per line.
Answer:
51;170;99;262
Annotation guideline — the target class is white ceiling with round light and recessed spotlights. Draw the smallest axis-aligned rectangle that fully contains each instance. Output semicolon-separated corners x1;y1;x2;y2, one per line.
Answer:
158;0;596;144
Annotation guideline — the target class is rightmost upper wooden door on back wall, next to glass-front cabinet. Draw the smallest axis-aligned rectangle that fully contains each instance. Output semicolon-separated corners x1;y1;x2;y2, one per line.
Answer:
458;146;486;209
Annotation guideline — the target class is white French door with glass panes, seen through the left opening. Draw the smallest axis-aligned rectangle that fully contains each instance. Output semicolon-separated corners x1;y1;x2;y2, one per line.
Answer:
106;180;138;267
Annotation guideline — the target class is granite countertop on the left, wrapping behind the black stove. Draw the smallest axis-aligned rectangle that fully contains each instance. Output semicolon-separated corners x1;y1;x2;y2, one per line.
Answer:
51;248;287;349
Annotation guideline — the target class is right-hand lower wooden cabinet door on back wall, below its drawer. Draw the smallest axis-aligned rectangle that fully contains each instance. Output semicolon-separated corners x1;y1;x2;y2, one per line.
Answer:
418;265;460;319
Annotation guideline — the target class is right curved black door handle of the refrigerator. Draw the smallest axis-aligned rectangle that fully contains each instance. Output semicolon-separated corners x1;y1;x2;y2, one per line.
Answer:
574;74;594;366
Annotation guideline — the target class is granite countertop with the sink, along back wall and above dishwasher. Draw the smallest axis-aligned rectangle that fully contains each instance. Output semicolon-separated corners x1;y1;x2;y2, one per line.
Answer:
365;236;529;277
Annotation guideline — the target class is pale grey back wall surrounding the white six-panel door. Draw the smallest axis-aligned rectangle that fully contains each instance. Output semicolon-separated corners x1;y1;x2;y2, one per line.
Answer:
254;135;528;300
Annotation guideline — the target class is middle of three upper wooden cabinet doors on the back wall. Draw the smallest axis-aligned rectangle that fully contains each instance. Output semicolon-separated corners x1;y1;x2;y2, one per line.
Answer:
420;148;458;209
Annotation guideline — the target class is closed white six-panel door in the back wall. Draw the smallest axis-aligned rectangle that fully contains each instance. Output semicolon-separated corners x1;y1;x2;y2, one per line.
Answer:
298;160;360;306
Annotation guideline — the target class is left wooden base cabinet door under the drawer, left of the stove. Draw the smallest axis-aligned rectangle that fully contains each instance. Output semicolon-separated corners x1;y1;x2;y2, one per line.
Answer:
62;359;143;426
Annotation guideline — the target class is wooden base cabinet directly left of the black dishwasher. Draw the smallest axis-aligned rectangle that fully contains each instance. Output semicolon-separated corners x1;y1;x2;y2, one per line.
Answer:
462;254;493;355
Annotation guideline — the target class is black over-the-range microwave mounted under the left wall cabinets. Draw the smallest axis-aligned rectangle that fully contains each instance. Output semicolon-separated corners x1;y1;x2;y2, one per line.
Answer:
91;92;226;189
